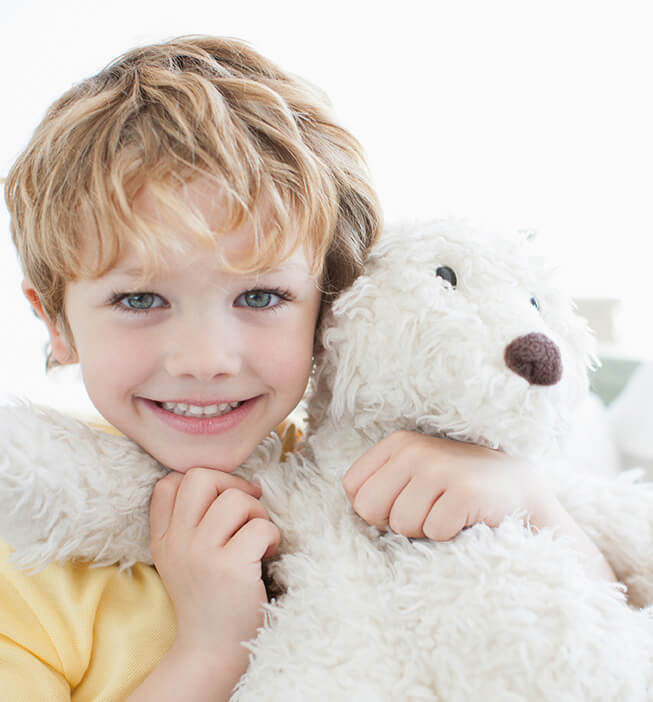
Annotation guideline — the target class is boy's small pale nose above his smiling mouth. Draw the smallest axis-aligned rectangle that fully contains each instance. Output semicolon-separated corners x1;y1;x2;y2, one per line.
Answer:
166;320;242;381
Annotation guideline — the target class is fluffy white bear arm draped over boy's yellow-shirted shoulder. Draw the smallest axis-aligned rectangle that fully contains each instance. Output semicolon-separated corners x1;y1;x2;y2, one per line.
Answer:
0;403;167;570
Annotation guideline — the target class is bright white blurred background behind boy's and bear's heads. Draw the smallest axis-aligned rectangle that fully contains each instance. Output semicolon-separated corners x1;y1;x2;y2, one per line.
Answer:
0;0;653;414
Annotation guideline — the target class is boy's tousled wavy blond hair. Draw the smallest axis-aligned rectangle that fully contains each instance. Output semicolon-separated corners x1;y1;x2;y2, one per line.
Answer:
5;36;381;368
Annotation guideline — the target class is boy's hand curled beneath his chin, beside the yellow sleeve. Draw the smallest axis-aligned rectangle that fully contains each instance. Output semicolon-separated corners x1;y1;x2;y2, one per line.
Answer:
150;468;280;683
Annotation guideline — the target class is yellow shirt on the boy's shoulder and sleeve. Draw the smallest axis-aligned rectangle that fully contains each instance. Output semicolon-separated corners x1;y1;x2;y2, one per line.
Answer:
0;542;175;702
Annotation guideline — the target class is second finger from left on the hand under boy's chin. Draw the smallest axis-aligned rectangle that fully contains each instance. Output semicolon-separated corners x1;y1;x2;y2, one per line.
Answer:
170;468;261;529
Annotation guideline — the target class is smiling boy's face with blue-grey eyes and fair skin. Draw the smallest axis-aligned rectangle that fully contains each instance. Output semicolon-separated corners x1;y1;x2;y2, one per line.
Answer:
35;182;320;472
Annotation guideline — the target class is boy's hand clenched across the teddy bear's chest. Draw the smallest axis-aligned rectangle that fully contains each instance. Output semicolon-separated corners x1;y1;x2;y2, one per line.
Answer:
343;431;554;541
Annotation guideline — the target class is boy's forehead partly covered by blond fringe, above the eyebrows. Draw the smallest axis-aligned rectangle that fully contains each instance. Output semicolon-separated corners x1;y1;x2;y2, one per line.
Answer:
70;178;319;283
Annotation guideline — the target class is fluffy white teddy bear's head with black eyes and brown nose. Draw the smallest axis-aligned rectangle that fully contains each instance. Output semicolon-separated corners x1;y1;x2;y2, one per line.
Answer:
308;222;595;455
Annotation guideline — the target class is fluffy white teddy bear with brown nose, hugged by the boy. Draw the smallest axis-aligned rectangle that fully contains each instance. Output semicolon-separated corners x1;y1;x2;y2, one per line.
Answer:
0;222;653;702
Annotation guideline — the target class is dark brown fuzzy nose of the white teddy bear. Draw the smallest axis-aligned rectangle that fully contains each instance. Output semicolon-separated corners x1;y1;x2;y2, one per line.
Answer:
504;333;562;385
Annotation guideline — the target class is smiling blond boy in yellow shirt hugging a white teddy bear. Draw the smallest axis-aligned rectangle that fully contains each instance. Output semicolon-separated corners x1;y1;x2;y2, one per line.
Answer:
0;37;610;702
